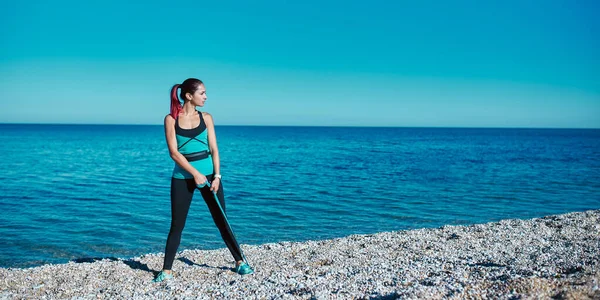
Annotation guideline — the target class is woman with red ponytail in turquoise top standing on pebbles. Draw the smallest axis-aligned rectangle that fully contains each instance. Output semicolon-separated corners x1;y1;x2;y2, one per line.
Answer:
154;78;254;282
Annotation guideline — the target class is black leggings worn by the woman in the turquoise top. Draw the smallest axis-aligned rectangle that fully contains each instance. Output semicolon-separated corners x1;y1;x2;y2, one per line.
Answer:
163;175;242;270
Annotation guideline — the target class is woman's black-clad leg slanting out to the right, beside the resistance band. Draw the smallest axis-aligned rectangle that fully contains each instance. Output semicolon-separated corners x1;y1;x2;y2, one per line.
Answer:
200;176;243;262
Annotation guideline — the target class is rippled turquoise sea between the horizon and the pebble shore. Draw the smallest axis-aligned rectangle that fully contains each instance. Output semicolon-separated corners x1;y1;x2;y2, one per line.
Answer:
0;124;600;267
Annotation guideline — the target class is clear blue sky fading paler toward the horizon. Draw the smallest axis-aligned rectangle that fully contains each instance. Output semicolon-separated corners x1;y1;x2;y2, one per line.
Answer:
0;0;600;128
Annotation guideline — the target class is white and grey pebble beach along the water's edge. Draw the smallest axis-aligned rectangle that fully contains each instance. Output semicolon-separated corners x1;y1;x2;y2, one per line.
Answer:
0;210;600;299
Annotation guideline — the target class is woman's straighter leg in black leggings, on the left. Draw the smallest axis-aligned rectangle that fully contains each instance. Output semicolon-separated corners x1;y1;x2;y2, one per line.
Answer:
163;178;196;270
